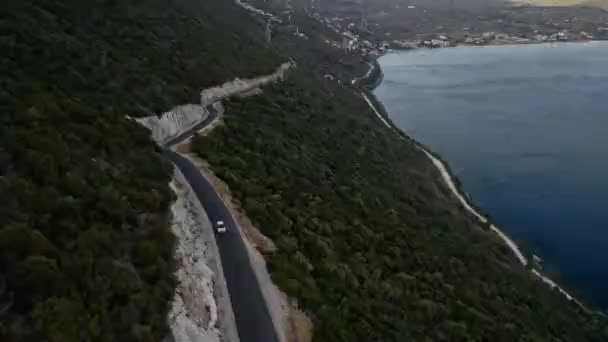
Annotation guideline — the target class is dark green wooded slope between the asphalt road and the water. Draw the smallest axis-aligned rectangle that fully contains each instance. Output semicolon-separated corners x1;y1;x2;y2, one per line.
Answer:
195;74;608;342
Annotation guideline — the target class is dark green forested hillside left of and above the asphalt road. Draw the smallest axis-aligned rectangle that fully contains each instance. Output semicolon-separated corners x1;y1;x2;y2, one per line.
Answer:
0;0;283;342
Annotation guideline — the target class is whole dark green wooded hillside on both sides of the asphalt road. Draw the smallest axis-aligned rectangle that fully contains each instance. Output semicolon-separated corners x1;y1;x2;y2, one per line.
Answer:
0;0;608;342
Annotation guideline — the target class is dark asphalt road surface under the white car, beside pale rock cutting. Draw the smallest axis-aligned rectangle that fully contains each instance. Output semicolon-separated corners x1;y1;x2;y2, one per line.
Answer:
163;150;279;342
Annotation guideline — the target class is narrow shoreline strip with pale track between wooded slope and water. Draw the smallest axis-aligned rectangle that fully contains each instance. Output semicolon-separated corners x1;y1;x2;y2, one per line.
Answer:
352;54;591;312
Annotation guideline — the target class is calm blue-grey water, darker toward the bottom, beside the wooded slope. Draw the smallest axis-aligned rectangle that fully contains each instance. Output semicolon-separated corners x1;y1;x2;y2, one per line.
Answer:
375;42;608;309
